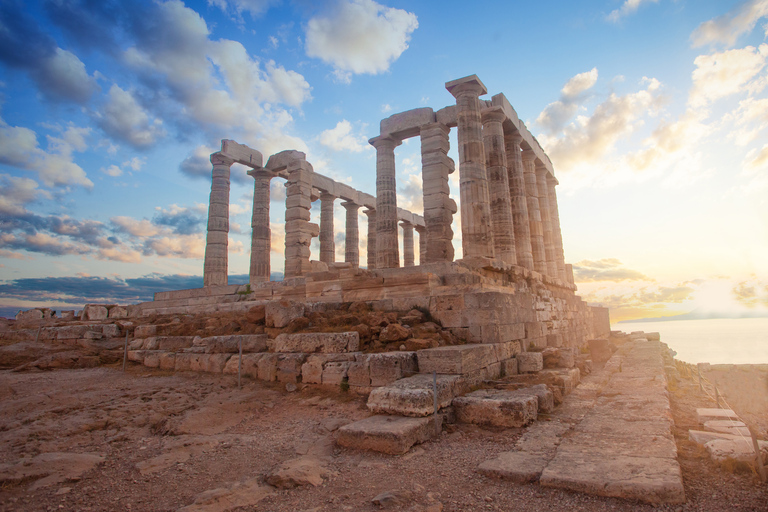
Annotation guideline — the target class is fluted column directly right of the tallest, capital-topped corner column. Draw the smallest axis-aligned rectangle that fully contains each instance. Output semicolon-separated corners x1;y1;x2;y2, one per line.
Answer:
481;107;517;265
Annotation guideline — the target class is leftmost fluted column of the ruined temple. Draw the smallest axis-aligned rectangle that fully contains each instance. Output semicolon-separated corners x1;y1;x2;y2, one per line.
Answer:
203;153;235;286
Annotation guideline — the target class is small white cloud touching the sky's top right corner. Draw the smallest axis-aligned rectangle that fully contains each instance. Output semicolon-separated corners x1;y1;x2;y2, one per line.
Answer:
691;0;768;47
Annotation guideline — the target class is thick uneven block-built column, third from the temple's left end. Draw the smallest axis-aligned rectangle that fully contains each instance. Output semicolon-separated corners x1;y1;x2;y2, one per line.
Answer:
285;160;320;278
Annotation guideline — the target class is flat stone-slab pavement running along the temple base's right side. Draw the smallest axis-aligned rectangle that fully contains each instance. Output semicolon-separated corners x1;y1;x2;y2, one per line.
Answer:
479;339;685;503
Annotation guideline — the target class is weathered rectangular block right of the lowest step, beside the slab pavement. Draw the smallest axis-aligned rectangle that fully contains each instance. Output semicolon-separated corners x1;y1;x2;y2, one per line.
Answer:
452;389;538;427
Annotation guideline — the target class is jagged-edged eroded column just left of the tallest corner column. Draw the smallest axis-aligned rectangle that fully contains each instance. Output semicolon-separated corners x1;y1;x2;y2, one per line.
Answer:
417;123;457;265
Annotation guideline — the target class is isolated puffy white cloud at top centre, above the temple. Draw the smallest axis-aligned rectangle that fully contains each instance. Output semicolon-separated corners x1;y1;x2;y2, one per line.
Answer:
306;0;419;82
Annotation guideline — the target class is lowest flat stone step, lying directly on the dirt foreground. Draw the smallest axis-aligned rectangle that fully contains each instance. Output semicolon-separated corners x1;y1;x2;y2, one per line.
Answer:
336;414;442;455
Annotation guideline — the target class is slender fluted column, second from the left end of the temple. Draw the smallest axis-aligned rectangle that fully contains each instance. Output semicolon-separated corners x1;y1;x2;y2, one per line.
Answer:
248;169;274;284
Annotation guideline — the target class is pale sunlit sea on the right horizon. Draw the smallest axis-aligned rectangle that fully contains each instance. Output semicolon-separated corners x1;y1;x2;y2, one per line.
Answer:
611;318;768;364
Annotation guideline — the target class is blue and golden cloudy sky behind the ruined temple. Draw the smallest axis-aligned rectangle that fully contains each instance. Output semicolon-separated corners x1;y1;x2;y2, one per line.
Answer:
0;0;768;321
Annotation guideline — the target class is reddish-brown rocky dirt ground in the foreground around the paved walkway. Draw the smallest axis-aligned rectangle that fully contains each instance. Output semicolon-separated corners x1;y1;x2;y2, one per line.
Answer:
0;354;768;512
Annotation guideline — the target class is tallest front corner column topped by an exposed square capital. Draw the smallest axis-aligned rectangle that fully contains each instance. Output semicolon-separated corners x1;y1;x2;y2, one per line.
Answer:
445;75;493;258
